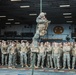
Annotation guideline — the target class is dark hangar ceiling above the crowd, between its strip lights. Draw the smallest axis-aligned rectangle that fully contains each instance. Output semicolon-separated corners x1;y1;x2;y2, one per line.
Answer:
0;0;76;26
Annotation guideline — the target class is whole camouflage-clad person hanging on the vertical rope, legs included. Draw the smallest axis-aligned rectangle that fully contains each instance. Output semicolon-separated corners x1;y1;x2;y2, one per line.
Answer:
33;12;50;47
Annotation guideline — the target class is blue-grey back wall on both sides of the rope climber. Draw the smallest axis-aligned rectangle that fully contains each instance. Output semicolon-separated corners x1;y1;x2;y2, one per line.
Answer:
1;24;73;41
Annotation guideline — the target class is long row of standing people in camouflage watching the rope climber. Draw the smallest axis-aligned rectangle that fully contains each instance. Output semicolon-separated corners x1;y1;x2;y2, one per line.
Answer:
0;40;76;69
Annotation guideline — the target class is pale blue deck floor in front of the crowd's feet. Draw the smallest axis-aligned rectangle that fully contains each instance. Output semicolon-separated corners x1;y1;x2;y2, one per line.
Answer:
0;66;76;75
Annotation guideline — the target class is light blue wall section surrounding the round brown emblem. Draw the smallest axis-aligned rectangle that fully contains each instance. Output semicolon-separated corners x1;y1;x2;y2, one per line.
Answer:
44;24;72;40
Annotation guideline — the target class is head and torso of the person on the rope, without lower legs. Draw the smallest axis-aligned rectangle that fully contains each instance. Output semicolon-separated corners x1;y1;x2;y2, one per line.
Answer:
36;12;50;36
